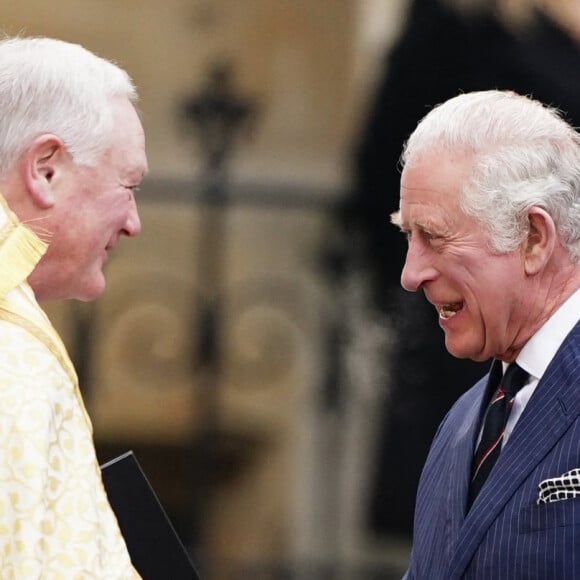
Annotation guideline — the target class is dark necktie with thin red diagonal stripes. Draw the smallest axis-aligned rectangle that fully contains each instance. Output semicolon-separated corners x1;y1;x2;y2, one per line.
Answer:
468;360;529;509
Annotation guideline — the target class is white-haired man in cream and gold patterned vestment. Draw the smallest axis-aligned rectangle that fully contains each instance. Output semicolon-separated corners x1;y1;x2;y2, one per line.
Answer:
0;38;147;580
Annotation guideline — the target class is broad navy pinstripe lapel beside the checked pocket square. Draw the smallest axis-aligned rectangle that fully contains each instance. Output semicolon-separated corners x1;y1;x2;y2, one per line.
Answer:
450;324;580;578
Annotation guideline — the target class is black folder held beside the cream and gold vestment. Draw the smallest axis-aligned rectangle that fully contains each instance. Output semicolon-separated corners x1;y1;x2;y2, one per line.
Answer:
101;451;199;580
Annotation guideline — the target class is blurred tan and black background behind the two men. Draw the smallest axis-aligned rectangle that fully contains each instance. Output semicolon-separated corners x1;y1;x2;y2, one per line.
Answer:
5;0;580;580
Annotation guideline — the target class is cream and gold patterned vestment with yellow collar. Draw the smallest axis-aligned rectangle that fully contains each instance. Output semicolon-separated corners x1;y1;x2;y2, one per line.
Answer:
0;196;139;580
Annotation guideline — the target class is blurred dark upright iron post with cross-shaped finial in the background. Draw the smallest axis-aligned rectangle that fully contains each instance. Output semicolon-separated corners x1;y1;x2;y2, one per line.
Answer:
182;62;254;560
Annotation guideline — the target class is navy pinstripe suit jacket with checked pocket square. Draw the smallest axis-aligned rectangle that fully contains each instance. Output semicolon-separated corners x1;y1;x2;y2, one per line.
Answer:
405;323;580;580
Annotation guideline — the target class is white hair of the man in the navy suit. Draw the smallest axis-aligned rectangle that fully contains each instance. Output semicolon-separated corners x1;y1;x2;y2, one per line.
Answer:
401;91;580;262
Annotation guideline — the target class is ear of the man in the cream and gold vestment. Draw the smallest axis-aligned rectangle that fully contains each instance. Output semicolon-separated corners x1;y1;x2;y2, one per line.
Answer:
19;133;68;209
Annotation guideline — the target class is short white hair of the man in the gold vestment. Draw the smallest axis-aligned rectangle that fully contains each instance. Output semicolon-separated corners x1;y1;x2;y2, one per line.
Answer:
0;37;137;175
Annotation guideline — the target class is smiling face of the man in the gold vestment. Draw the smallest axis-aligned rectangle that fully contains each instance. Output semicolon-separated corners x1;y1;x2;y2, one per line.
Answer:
29;99;147;300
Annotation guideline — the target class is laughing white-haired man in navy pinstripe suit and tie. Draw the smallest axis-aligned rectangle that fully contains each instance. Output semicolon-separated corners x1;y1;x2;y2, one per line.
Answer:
392;91;580;580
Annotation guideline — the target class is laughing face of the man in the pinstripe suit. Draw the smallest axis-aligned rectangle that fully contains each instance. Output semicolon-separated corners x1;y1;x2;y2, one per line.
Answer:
393;154;531;360
